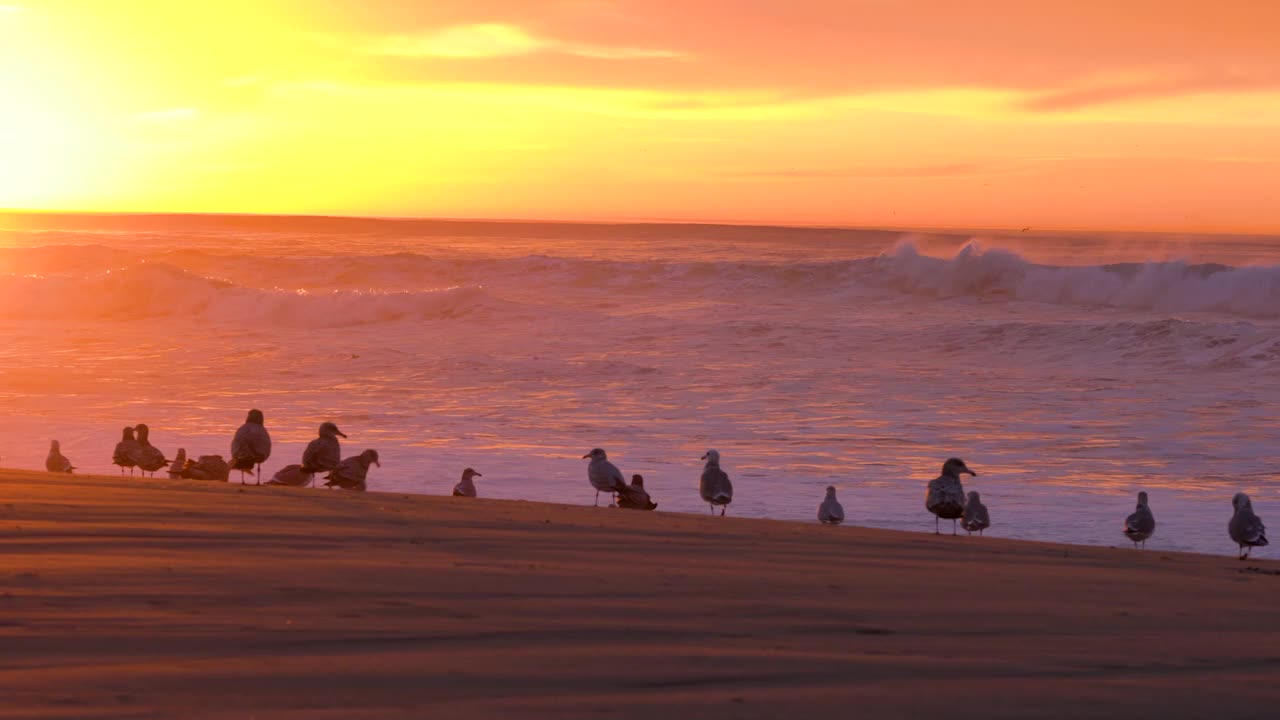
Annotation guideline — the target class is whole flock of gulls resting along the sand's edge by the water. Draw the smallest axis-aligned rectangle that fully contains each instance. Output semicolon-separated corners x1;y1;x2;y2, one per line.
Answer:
35;410;1268;560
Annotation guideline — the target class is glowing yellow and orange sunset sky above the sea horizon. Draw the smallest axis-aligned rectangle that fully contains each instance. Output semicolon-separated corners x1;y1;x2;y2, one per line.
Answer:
0;0;1280;233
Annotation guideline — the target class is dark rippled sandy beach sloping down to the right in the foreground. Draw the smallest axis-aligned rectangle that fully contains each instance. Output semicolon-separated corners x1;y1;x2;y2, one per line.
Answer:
0;470;1280;719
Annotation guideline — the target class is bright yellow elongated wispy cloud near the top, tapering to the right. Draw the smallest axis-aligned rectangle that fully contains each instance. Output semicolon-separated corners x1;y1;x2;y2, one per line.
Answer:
367;23;685;60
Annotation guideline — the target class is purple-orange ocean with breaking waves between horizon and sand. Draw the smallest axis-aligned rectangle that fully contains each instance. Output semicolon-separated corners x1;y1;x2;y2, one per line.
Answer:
0;215;1280;556
